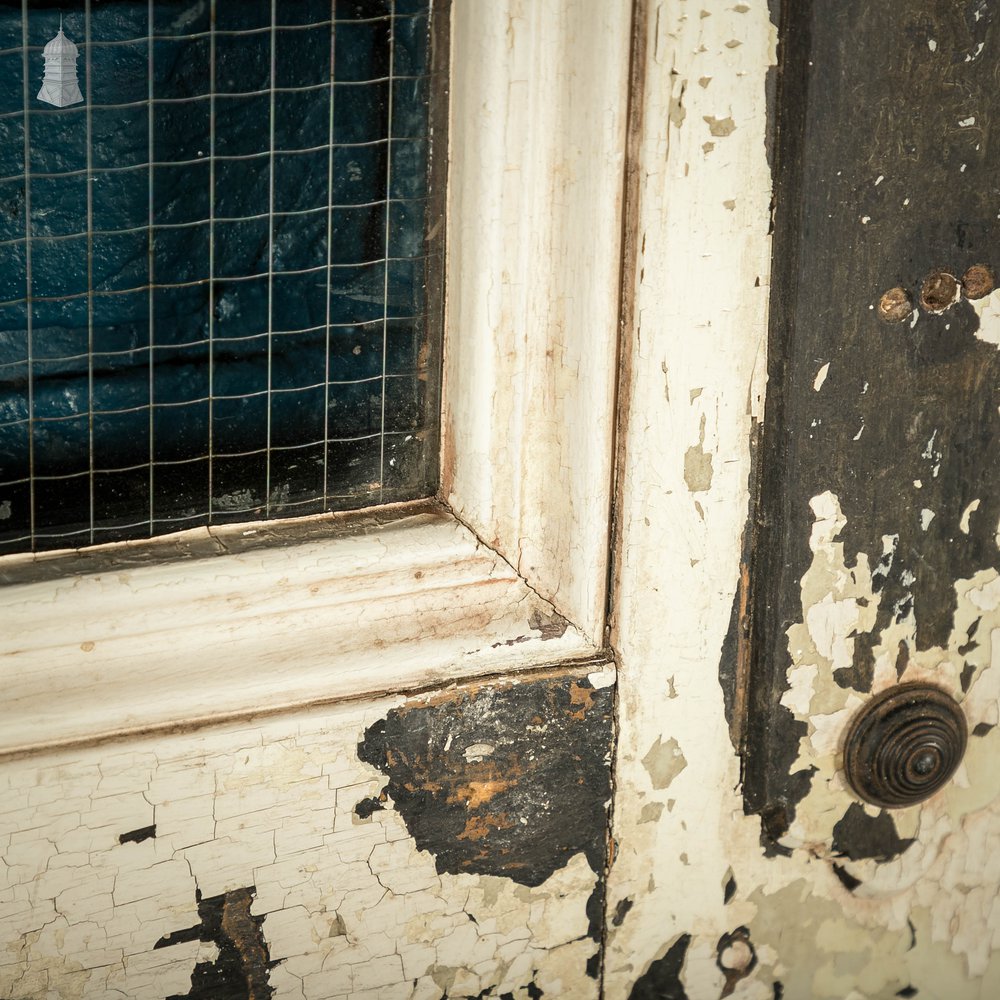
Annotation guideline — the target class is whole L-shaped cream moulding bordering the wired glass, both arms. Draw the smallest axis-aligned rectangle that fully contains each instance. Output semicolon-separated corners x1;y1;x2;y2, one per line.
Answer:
0;0;631;755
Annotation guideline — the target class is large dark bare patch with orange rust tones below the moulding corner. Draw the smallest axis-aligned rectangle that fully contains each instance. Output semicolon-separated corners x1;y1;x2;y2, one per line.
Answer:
358;673;612;886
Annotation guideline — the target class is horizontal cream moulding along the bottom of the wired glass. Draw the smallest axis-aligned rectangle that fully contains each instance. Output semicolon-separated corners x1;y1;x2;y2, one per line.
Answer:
0;503;596;755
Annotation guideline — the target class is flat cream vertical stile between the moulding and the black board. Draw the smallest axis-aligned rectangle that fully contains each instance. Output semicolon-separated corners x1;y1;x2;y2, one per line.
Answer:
605;0;776;1000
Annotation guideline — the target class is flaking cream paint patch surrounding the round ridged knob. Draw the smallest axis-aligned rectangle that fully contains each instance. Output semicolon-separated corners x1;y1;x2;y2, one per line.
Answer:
755;492;1000;996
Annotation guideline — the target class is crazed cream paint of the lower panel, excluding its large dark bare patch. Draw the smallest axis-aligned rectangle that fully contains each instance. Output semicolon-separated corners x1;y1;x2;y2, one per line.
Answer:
0;671;612;1000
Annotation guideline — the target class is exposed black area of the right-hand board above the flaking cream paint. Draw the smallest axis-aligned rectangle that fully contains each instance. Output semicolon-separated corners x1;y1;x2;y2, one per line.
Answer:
742;0;1000;844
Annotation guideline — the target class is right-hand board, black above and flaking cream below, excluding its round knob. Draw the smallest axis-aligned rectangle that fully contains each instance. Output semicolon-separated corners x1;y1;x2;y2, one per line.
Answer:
737;0;1000;997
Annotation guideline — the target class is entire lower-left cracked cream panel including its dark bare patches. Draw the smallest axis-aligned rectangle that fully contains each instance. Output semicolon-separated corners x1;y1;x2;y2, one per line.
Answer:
0;668;614;1000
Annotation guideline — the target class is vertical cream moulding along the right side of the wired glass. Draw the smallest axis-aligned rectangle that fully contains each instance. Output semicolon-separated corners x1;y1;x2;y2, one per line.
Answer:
441;0;632;637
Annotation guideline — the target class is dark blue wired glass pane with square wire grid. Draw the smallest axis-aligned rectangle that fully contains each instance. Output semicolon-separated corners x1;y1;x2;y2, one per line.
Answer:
0;0;438;552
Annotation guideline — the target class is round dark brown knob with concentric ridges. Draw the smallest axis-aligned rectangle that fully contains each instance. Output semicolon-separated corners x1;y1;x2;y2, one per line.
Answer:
844;684;968;809
